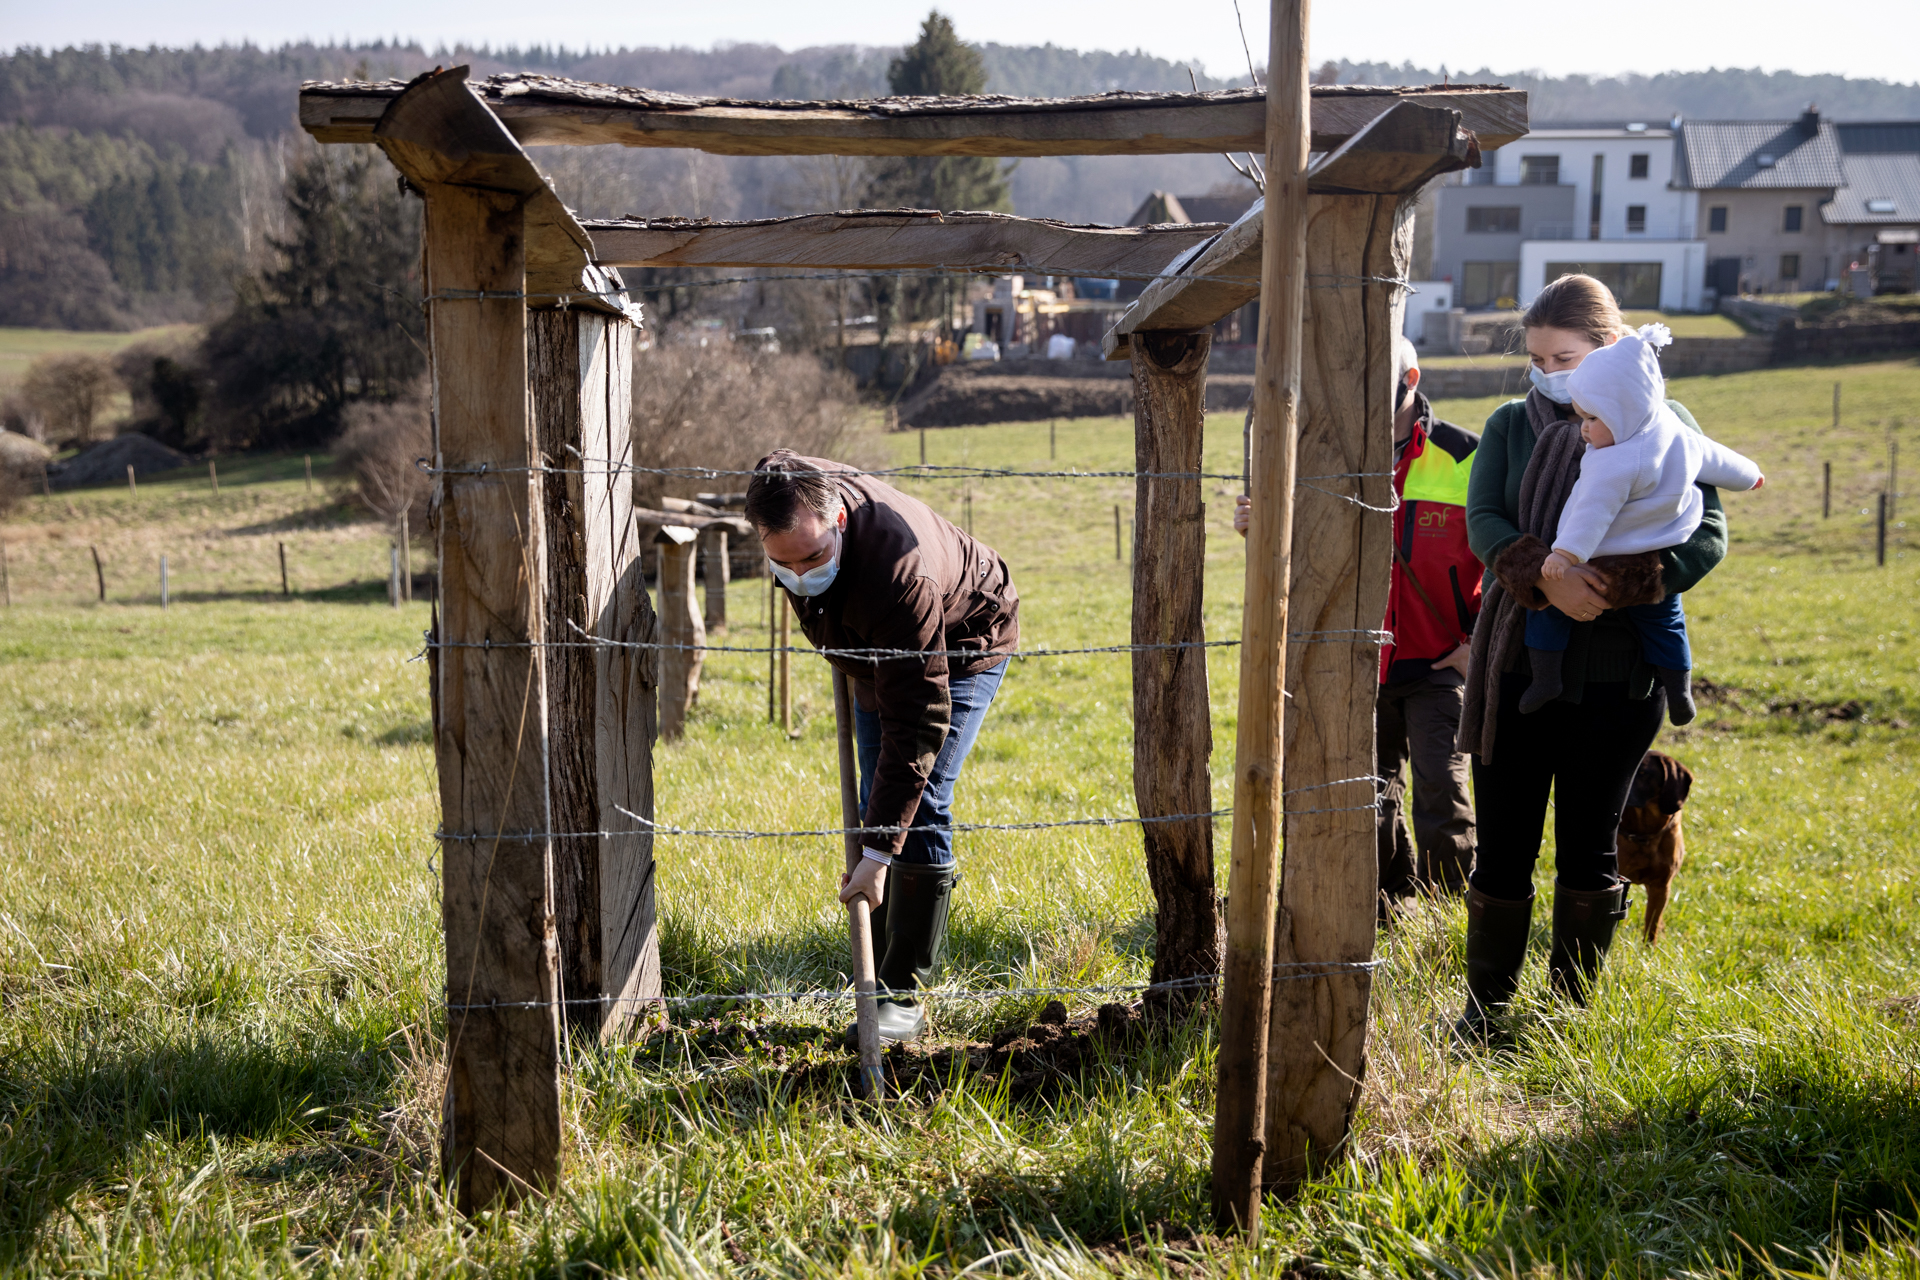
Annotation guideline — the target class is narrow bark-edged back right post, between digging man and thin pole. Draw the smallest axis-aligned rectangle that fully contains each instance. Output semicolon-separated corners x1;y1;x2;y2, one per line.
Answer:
1131;332;1219;1007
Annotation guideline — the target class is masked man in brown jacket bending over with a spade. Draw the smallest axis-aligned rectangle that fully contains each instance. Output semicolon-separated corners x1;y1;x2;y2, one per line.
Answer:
745;449;1020;1048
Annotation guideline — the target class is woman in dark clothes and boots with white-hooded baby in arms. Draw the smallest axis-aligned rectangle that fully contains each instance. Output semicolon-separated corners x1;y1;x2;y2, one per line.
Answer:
1455;276;1764;1044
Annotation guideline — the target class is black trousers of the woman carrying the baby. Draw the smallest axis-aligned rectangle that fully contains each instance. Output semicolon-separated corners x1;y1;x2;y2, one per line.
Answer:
1473;672;1667;902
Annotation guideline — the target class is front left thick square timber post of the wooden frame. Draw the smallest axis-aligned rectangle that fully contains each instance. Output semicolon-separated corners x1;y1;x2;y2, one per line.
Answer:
424;182;561;1213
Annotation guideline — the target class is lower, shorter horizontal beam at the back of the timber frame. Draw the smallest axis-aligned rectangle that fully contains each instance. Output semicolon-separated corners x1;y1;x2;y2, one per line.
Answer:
584;209;1225;276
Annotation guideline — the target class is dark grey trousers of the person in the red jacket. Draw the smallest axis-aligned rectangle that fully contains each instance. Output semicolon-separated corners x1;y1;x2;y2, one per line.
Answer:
1375;679;1475;898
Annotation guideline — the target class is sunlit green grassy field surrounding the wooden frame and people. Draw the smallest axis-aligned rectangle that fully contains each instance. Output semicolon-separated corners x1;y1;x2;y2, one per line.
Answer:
0;361;1920;1280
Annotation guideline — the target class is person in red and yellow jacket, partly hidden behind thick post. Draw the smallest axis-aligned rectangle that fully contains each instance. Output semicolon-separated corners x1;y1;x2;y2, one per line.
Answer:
1235;338;1484;915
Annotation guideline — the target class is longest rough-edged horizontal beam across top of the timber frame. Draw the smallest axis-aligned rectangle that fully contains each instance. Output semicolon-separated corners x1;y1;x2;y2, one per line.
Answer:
300;75;1526;155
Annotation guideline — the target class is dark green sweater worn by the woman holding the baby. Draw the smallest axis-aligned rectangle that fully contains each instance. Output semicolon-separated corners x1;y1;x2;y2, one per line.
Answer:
1467;399;1726;702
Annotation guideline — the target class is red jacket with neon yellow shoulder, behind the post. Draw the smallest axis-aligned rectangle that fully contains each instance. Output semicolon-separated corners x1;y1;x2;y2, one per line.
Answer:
1380;391;1484;685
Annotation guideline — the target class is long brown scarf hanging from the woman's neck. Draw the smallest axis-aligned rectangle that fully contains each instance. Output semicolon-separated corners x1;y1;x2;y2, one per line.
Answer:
1459;391;1586;762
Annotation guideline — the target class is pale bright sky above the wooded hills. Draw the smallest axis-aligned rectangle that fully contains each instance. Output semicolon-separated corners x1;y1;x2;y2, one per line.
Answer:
0;0;1920;81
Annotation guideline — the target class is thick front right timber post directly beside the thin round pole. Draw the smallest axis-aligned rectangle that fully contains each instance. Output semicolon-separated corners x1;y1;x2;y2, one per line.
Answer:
1265;196;1413;1194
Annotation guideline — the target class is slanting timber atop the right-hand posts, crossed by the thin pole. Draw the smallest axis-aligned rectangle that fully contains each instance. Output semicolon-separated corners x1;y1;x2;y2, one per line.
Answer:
1100;102;1478;361
